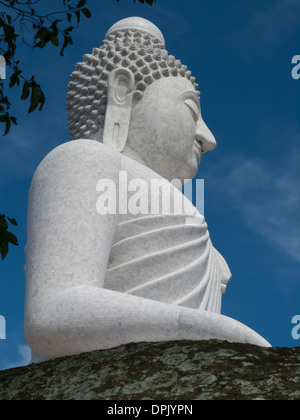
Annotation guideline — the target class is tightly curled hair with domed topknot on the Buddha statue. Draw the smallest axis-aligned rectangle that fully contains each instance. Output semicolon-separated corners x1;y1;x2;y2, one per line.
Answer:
67;18;198;140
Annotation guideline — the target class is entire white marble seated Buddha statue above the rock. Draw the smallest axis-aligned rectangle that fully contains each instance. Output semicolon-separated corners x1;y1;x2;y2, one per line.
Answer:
25;18;269;361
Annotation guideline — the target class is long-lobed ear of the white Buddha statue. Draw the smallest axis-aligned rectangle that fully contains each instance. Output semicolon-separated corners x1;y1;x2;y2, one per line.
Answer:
103;67;135;152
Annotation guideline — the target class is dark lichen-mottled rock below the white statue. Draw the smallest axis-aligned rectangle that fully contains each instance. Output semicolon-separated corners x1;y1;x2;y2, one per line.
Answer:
0;341;300;400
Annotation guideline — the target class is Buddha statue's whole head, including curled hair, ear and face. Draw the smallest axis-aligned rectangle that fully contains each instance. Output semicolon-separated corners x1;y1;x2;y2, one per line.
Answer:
68;18;216;180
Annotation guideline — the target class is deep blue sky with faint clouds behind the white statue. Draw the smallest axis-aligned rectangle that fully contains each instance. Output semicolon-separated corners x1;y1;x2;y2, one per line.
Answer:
0;0;300;370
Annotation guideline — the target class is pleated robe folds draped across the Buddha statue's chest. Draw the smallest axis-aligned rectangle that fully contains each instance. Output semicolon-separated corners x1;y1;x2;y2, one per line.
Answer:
104;215;212;303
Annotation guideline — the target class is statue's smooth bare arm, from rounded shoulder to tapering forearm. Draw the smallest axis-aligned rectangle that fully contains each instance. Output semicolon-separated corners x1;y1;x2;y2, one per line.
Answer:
25;141;270;357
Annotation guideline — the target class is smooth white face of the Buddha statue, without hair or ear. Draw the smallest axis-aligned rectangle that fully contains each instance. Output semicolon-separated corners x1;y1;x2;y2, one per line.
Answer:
123;77;216;181
